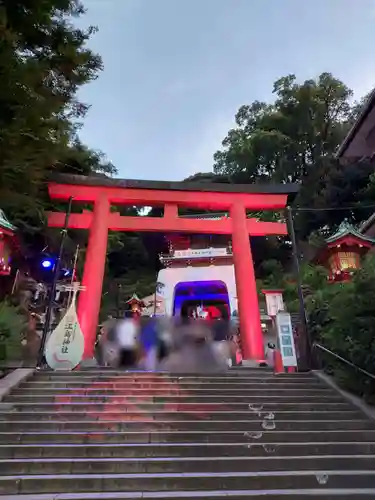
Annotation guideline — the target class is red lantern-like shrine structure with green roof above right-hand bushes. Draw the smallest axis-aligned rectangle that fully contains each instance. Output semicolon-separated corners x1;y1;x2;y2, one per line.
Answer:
314;221;375;282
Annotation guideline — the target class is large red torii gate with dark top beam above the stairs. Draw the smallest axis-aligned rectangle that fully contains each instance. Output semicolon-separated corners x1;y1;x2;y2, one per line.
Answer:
48;175;298;360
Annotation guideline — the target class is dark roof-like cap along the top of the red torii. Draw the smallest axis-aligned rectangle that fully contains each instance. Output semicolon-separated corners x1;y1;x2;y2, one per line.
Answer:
49;174;299;202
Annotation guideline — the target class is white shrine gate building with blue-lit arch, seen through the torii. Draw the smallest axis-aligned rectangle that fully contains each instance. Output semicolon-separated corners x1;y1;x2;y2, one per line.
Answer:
157;213;238;319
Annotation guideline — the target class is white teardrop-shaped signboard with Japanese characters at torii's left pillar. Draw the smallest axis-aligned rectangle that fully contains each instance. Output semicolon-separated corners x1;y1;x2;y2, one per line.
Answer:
45;293;85;371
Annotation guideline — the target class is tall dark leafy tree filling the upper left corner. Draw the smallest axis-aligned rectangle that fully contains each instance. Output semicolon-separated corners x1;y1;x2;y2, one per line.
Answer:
0;0;102;234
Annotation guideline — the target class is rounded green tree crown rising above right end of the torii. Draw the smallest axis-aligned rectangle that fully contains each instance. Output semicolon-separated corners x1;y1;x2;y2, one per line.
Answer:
214;73;352;182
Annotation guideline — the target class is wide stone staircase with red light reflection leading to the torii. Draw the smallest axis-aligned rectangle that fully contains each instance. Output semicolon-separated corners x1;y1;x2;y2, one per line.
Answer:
0;368;375;500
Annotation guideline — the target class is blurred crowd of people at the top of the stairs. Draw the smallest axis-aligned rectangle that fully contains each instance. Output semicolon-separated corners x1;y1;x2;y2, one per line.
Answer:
97;314;241;373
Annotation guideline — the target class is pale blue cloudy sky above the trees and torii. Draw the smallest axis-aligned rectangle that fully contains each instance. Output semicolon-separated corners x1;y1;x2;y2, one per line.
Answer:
80;0;375;180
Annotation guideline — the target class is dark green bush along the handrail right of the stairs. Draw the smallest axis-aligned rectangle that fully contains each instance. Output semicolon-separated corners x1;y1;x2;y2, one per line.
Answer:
306;256;375;403
